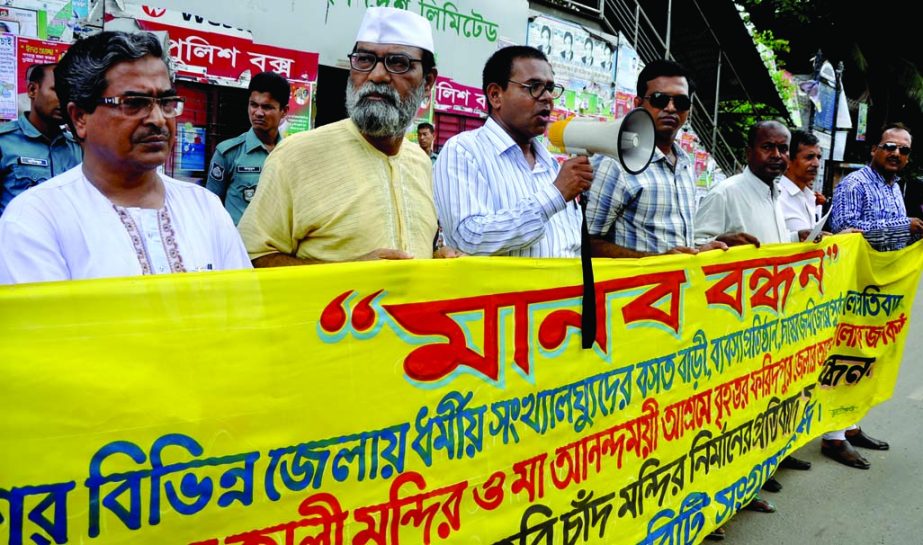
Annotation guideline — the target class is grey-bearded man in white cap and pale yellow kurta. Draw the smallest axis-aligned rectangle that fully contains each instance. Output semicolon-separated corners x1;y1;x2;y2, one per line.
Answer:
238;8;454;267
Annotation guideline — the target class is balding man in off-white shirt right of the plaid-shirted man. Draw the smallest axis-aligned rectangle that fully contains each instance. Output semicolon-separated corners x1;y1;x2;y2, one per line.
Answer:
695;121;807;245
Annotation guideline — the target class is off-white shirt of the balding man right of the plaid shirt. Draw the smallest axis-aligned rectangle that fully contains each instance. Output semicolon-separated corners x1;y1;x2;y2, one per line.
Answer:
695;168;798;244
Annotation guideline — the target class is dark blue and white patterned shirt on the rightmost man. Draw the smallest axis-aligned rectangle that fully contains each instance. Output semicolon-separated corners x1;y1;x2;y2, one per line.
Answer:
830;165;919;252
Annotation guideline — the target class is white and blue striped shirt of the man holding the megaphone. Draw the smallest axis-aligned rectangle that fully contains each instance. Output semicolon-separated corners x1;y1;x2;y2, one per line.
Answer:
433;119;581;257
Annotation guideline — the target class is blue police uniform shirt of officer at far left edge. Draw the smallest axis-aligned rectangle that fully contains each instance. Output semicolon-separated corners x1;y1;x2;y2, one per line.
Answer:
0;114;83;214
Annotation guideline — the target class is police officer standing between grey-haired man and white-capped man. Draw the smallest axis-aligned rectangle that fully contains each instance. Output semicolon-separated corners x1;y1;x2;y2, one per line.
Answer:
205;72;291;225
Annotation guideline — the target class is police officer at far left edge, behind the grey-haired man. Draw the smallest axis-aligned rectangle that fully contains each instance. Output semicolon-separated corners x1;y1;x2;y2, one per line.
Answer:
0;64;82;214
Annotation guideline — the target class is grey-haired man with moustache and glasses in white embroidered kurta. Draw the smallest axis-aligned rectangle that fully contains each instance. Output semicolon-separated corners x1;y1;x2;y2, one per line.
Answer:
0;32;250;284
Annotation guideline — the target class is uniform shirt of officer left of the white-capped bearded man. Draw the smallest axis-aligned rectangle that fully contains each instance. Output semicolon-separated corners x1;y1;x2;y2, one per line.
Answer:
205;128;282;225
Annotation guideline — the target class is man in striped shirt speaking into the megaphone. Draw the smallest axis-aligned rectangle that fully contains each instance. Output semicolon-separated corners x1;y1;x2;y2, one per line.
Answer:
434;46;593;257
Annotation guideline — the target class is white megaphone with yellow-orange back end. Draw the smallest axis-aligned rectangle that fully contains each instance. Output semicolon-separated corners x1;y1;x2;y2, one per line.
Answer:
548;108;655;174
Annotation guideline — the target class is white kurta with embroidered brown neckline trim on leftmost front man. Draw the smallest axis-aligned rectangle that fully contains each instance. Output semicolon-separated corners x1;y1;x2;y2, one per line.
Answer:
0;165;251;284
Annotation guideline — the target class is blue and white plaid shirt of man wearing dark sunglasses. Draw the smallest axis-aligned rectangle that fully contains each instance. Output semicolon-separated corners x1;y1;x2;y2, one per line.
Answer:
587;143;695;254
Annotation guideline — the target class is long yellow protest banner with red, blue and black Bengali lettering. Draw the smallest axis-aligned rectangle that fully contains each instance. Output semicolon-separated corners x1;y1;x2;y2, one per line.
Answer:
0;235;923;545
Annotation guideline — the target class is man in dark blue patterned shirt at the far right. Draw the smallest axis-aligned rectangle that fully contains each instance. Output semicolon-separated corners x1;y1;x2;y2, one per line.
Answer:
830;123;923;251
